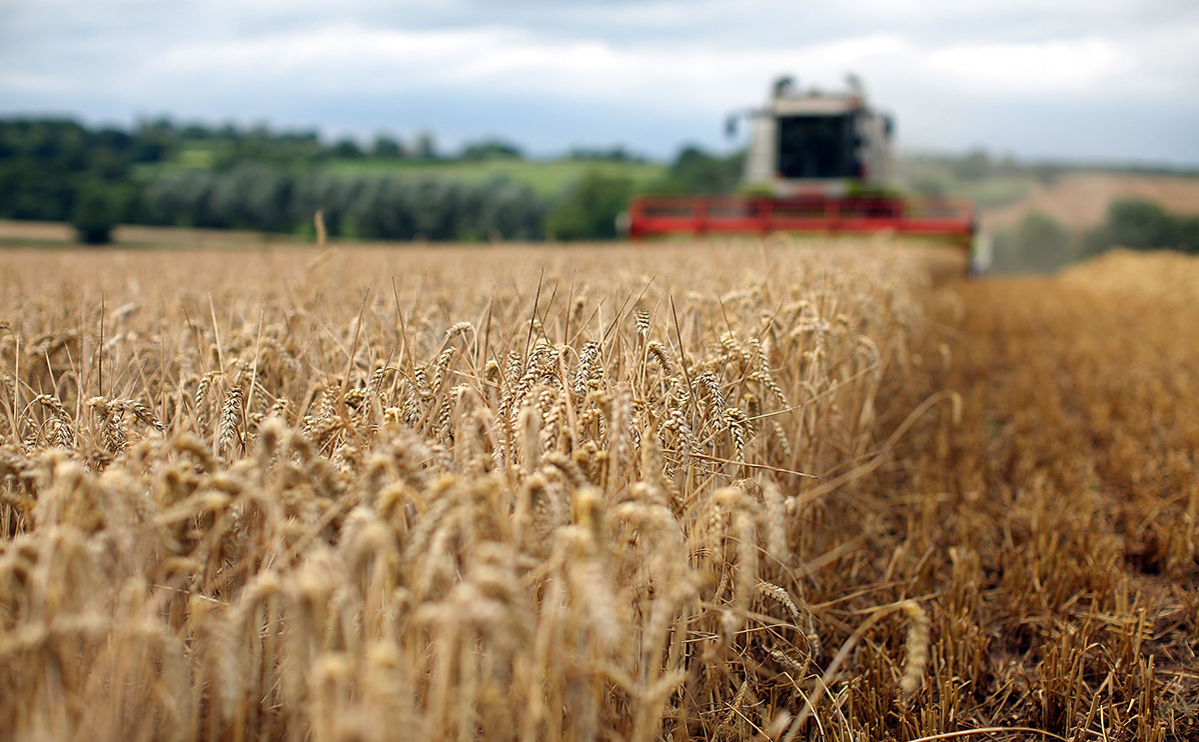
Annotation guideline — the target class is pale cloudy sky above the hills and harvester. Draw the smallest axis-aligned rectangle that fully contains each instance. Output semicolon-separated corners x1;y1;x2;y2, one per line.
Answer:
0;0;1199;165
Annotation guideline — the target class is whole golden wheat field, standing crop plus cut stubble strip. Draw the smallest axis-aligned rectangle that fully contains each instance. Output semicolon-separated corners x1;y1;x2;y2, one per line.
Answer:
0;242;1199;742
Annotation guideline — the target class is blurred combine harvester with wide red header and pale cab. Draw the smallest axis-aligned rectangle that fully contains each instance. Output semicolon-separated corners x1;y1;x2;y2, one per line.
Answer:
626;76;989;271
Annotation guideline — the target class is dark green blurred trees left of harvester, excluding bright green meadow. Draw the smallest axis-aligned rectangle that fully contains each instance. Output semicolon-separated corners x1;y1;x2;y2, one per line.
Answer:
0;119;741;243
